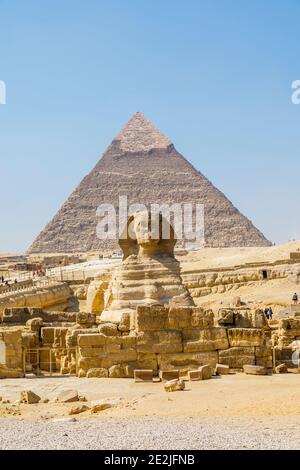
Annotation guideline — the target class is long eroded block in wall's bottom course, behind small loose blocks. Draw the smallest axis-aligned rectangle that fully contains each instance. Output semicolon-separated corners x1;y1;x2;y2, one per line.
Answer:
158;351;218;375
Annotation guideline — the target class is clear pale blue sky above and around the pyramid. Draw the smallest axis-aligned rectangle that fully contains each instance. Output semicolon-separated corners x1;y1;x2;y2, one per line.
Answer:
0;0;300;252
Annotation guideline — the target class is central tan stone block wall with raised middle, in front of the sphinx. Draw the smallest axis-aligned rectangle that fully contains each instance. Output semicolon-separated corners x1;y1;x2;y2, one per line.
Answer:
72;307;272;377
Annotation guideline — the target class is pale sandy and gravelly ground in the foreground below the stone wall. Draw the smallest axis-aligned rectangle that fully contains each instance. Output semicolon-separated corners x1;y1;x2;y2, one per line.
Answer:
0;374;300;450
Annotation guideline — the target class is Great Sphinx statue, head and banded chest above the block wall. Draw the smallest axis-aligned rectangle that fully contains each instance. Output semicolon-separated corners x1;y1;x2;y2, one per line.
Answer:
86;211;194;323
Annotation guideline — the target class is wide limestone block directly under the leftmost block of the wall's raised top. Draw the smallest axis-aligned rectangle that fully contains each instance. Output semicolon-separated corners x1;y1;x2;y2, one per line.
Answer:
137;330;182;354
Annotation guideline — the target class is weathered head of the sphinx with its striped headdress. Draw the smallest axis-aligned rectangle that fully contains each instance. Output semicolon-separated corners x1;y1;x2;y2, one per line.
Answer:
119;211;176;259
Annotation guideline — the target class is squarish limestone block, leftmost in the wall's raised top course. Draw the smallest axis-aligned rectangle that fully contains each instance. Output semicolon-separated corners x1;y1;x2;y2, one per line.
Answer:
135;306;168;331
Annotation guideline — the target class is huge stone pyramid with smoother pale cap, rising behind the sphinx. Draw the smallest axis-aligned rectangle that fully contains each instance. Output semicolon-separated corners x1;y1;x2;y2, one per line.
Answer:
28;113;271;253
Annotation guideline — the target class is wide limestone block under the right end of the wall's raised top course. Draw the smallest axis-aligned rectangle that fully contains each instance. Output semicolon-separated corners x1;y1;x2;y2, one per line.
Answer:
182;327;229;352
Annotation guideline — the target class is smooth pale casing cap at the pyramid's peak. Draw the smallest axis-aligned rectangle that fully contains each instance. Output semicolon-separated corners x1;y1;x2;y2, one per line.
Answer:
115;111;172;152
